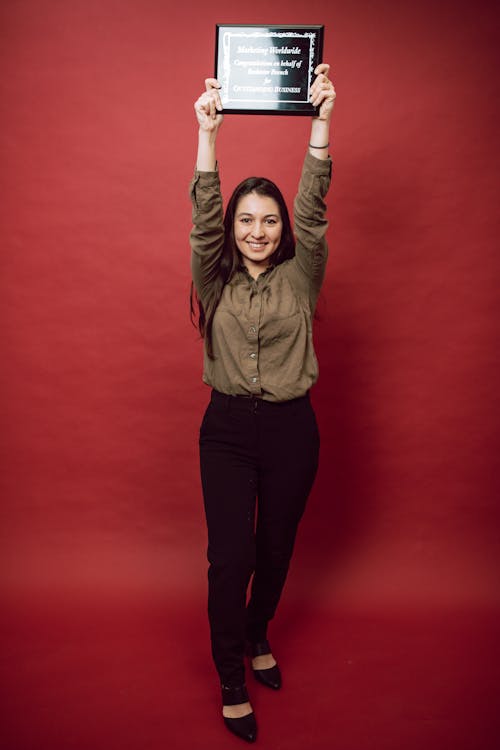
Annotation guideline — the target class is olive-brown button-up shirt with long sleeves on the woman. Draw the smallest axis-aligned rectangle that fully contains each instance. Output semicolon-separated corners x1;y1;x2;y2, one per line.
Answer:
190;153;332;401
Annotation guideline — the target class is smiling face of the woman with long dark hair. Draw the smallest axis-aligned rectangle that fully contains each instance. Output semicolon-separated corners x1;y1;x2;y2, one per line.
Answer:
234;193;283;277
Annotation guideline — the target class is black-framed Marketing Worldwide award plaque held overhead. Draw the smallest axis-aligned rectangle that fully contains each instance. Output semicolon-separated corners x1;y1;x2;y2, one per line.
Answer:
215;24;325;115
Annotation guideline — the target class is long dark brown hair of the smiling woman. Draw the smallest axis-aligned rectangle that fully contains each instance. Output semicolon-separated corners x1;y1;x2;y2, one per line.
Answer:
190;177;295;359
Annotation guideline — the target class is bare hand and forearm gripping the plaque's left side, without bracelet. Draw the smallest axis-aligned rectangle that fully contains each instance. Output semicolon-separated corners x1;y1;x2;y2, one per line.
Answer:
194;78;224;172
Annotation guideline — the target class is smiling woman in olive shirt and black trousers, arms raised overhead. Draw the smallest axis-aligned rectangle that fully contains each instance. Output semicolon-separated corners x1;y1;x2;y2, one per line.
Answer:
191;63;335;742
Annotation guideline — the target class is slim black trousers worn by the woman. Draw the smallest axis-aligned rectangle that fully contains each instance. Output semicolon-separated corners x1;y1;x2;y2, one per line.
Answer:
200;391;319;687
